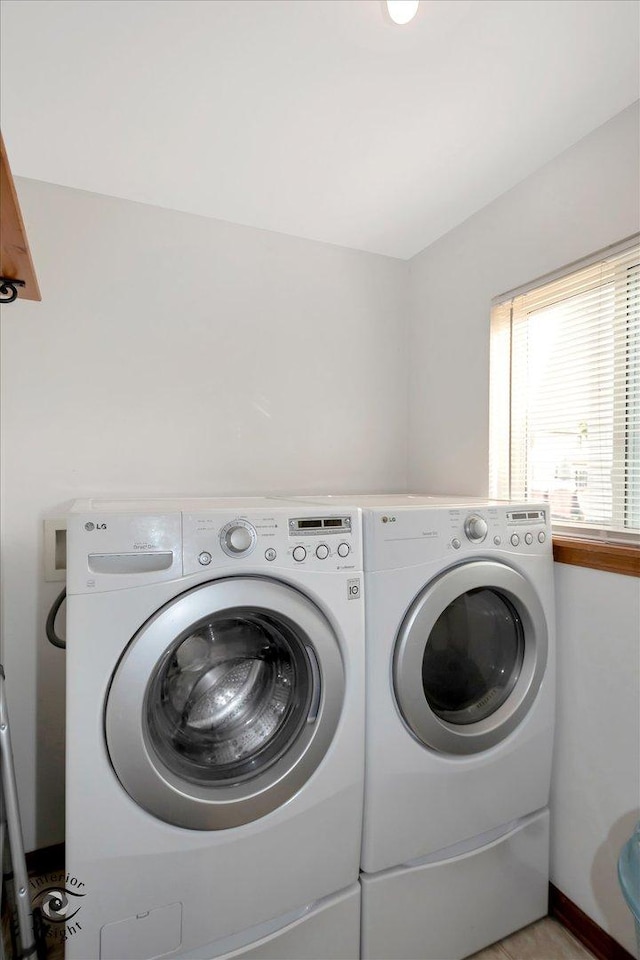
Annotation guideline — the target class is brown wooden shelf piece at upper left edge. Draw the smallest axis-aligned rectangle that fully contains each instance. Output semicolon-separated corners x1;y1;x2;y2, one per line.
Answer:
0;135;42;302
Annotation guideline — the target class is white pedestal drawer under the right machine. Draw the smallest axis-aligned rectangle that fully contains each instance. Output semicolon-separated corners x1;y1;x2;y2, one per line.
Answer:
360;809;549;960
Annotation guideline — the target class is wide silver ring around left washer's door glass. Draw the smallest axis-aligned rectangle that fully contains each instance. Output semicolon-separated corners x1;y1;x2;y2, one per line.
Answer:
105;577;345;830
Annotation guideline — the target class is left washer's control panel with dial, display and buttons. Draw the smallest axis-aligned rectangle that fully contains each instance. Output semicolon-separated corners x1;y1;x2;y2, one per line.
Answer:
183;505;362;574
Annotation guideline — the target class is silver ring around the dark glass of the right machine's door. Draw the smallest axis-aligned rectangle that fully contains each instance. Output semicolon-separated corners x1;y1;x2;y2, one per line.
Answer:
393;560;549;754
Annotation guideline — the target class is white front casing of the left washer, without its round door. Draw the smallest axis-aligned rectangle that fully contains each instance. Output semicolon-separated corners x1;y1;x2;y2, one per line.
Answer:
66;502;364;960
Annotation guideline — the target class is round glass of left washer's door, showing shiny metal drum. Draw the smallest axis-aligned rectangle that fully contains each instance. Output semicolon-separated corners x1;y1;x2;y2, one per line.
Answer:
146;611;317;785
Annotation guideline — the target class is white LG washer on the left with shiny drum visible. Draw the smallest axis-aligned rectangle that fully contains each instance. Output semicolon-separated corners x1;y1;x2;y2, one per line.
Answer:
66;498;364;960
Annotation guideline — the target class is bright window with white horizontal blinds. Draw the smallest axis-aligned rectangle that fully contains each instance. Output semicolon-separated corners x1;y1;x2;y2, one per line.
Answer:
489;238;640;541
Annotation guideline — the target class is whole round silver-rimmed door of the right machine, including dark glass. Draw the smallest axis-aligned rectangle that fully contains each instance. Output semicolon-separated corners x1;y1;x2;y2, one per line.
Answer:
393;560;548;754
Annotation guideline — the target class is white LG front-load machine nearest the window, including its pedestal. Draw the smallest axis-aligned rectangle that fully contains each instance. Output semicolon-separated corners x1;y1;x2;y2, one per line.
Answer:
284;495;555;960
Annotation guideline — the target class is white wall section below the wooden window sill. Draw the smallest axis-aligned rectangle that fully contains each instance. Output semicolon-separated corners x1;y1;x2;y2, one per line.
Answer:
551;563;640;952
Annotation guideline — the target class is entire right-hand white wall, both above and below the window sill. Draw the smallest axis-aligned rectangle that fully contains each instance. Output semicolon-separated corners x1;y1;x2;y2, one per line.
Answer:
408;105;640;951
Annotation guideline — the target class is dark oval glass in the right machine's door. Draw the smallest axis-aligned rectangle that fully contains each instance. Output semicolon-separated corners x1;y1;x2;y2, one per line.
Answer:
422;587;525;724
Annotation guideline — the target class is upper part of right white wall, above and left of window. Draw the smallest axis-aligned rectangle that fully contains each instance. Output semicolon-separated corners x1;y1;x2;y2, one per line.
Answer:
409;104;640;494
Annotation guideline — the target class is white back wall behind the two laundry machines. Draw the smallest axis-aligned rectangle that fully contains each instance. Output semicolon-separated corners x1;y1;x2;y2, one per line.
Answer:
2;180;408;849
